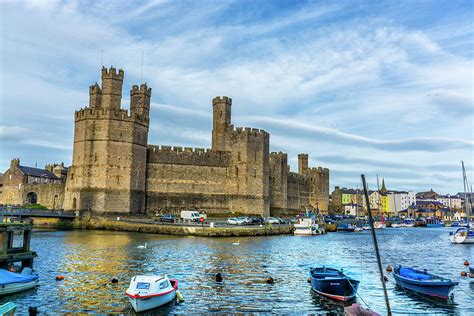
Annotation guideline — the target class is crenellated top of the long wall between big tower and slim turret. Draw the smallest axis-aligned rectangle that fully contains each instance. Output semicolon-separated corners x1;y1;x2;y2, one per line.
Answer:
147;145;230;167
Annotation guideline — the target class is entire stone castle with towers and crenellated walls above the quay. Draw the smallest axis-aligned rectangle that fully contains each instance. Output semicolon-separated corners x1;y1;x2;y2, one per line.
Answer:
0;67;329;216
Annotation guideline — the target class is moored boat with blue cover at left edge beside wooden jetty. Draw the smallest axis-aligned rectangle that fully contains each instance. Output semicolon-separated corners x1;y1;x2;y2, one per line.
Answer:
0;268;39;296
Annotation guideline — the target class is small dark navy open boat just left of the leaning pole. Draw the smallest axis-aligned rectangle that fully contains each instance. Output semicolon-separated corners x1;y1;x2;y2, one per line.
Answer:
309;266;360;302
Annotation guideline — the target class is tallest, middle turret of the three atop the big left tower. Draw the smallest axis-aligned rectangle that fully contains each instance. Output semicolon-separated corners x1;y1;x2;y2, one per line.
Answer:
102;66;124;109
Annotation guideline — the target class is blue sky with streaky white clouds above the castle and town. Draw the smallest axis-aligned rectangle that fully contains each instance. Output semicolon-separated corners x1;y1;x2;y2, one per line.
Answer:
0;0;474;193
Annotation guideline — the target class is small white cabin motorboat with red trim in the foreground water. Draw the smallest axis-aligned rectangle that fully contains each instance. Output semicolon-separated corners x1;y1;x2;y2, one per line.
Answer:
125;275;178;312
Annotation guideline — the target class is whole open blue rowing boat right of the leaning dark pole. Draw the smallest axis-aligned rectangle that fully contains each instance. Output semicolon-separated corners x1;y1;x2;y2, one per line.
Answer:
393;266;459;299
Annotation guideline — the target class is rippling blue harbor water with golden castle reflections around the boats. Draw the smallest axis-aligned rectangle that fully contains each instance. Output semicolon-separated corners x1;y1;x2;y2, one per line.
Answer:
0;228;474;315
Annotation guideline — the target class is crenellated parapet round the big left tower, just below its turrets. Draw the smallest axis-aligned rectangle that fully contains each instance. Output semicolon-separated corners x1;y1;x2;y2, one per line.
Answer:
74;107;150;125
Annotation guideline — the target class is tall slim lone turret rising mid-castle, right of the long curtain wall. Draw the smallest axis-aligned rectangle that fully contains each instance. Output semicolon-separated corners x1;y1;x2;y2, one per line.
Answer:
212;96;233;151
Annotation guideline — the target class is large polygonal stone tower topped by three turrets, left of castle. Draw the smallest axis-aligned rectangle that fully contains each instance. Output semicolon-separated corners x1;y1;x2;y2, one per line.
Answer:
64;67;151;213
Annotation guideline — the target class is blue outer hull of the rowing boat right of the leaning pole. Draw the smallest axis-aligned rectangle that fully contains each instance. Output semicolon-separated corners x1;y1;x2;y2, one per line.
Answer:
393;268;458;299
